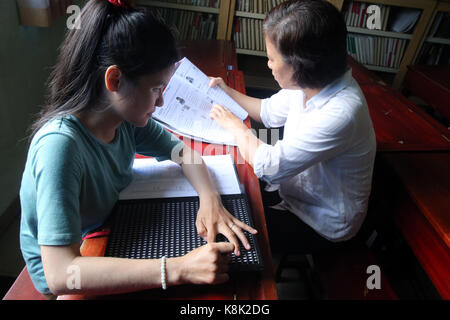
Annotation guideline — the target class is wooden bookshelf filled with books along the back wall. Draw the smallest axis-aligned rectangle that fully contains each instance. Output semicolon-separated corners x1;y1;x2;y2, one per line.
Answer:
135;0;450;89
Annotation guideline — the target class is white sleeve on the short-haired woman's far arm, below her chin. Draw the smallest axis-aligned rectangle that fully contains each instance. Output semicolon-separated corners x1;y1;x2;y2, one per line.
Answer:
260;89;293;128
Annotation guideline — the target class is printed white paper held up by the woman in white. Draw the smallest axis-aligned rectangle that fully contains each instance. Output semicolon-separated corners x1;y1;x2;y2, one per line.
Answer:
153;58;248;145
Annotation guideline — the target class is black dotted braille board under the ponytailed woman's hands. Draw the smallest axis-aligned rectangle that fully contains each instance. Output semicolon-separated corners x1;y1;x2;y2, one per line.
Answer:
105;195;263;271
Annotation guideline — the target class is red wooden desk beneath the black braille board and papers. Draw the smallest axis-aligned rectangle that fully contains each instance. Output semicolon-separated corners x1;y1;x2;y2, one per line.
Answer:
63;41;277;300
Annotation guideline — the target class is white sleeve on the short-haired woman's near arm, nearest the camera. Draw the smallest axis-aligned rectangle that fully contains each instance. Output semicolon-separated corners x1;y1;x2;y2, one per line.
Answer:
253;106;354;184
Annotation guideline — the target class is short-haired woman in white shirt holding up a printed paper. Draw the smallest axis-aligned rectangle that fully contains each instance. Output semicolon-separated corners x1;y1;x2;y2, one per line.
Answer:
210;0;376;252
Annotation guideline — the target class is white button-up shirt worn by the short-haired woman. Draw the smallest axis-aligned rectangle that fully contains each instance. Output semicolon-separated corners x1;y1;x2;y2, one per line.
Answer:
254;70;376;241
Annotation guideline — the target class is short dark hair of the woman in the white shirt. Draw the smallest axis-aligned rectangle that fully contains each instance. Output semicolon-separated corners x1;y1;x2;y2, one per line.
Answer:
264;0;347;89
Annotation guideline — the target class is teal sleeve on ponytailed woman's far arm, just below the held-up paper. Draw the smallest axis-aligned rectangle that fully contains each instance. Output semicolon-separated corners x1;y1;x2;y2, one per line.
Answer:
134;118;184;161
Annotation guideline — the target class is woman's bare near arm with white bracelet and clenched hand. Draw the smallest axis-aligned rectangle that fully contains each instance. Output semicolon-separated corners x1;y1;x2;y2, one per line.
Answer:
41;242;234;295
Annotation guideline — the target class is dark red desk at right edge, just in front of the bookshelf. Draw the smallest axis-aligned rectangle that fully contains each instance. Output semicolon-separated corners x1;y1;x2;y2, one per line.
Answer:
403;65;450;120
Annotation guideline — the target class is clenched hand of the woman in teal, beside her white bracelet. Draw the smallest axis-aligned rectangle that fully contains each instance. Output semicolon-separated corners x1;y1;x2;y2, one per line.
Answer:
171;242;234;284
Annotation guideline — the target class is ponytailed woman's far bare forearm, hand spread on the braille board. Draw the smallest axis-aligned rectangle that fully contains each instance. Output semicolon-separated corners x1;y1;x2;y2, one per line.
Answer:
178;146;257;255
